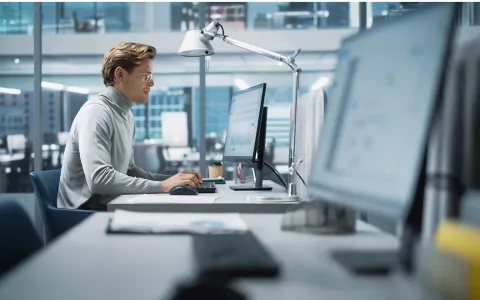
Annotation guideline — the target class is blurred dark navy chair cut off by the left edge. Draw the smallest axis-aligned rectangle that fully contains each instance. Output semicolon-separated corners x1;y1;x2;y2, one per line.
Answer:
0;201;43;278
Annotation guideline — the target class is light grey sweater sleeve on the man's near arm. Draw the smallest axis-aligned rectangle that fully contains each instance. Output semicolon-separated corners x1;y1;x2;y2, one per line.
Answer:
77;104;160;194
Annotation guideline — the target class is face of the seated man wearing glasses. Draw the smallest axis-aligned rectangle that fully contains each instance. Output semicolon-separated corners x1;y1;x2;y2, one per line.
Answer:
121;59;155;103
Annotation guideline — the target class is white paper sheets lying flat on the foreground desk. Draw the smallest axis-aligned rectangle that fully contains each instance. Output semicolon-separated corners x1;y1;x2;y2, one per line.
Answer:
109;209;248;234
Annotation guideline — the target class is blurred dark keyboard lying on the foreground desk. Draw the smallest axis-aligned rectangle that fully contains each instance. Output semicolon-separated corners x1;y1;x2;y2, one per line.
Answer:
193;232;280;278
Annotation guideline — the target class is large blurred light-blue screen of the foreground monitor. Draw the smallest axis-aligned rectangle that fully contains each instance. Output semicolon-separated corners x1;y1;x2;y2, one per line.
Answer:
309;3;455;217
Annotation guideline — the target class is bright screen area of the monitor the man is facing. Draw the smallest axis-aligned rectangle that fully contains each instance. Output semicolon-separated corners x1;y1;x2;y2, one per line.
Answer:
223;83;267;162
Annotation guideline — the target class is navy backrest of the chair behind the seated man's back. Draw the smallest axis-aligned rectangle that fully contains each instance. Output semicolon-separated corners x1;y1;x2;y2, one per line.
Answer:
30;169;61;211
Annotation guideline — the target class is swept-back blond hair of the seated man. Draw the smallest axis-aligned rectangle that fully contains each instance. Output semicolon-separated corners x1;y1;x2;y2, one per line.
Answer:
102;43;157;86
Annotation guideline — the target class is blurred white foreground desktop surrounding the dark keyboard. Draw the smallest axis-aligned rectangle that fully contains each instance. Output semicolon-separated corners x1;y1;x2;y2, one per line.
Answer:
0;213;411;300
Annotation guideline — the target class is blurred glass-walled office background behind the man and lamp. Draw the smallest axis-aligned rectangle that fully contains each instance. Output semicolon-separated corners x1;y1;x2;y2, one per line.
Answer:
0;0;480;193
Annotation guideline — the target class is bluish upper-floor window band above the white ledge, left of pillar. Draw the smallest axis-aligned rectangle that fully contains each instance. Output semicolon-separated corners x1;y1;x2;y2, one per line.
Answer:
0;0;356;34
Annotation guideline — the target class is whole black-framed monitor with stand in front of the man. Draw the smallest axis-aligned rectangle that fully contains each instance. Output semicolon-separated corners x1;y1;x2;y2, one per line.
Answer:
223;83;272;190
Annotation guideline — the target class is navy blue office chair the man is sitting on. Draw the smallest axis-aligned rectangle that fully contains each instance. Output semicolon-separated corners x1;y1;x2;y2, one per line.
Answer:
30;169;93;243
